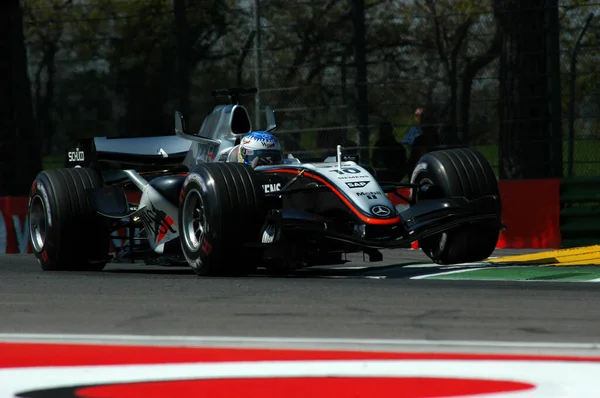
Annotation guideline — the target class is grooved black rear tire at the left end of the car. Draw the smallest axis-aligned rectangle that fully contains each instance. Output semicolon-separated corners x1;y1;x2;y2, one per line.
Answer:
28;167;110;271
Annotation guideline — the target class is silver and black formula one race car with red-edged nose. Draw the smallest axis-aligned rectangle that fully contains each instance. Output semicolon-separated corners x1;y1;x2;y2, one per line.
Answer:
29;88;503;275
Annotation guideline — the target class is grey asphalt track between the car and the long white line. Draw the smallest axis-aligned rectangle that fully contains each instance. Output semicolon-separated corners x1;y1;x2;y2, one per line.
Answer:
0;250;600;343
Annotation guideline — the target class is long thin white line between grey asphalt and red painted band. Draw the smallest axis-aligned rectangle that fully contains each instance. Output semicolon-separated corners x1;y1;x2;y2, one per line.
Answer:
0;333;600;350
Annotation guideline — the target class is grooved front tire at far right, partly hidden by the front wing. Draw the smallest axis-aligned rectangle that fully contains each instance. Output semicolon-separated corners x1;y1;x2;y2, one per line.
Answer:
411;148;502;264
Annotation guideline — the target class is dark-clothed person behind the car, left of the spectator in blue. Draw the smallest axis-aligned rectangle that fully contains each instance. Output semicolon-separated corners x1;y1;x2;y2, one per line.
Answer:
372;121;406;182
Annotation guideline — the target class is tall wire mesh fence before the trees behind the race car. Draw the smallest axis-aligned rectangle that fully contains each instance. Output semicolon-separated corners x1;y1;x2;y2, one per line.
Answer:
16;0;600;175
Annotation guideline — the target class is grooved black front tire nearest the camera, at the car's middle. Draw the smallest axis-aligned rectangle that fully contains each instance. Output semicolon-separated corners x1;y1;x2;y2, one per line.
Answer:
179;163;267;276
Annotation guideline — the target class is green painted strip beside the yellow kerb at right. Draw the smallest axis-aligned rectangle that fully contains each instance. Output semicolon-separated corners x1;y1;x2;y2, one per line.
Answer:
419;266;600;282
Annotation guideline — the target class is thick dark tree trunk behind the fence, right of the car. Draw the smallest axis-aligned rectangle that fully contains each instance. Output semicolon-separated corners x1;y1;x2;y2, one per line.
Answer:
495;0;562;179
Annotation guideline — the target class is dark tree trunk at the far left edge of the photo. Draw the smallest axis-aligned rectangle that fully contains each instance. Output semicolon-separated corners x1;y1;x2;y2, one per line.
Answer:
0;0;42;196
